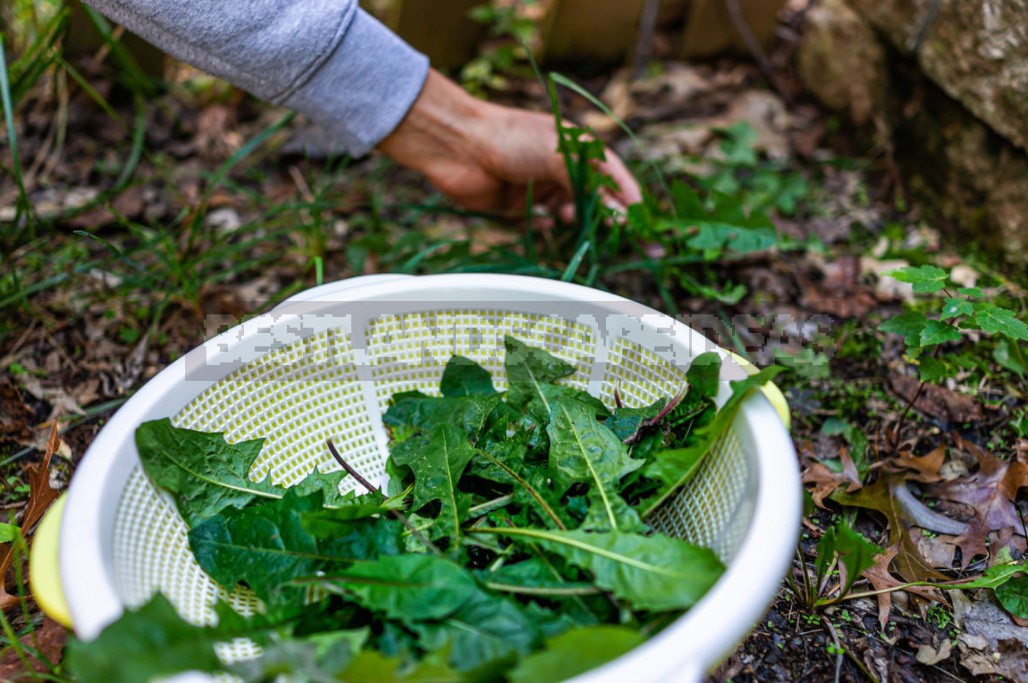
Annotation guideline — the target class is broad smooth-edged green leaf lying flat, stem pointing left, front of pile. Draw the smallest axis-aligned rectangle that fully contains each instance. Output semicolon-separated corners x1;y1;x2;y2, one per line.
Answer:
303;554;479;621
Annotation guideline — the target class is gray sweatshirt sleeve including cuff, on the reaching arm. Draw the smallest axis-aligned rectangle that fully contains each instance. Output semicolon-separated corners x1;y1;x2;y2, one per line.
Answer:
86;0;429;155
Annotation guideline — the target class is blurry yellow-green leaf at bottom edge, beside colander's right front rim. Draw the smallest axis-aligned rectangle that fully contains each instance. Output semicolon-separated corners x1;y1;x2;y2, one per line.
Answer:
508;625;643;683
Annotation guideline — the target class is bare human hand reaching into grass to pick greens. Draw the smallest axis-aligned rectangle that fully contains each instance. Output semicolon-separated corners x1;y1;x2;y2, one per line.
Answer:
378;69;643;220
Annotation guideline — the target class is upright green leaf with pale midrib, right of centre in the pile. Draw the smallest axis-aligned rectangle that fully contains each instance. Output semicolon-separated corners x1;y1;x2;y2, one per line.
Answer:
546;399;643;522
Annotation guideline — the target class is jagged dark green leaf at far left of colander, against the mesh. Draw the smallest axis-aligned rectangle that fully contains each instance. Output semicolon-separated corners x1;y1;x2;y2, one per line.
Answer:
136;418;347;528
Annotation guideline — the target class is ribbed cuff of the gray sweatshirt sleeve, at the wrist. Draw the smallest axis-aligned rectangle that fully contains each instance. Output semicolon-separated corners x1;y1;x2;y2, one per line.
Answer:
283;9;429;156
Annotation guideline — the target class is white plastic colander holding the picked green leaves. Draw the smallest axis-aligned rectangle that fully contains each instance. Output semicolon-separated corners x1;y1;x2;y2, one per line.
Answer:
48;275;801;683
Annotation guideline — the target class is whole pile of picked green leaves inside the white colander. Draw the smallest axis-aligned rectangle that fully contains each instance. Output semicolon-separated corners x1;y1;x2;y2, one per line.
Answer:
65;337;779;683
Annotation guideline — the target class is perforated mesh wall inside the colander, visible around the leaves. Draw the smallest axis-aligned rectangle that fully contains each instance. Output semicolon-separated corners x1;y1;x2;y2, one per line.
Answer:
113;303;754;659
